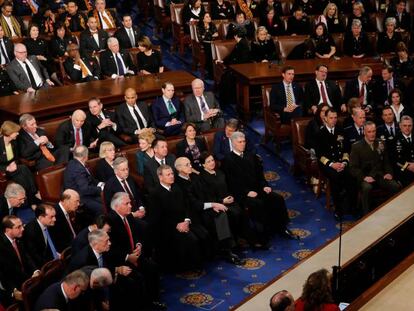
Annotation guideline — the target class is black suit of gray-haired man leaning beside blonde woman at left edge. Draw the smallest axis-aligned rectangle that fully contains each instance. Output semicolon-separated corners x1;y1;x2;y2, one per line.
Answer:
17;128;69;170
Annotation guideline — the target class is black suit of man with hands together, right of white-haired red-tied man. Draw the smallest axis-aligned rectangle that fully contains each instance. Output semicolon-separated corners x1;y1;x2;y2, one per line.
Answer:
86;110;126;147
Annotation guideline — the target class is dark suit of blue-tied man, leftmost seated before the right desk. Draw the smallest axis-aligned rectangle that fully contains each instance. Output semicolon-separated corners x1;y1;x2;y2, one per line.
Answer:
270;82;303;124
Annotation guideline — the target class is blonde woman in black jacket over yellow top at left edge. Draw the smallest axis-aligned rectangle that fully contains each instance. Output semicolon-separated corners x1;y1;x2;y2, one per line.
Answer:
0;121;37;204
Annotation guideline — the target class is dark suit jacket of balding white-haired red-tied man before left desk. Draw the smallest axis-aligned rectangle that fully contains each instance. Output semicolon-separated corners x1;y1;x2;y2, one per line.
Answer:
56;120;96;148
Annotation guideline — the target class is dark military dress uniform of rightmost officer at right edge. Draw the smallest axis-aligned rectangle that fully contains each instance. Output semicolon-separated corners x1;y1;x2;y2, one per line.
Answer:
392;133;414;187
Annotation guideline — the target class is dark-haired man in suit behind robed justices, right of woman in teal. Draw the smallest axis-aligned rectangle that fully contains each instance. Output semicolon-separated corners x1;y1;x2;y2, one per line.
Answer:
144;139;175;192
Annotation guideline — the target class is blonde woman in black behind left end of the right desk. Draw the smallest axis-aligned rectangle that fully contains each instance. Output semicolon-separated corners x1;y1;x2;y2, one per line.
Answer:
251;26;278;63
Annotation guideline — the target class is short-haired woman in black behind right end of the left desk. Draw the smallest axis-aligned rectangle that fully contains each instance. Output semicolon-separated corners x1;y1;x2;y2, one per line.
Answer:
137;36;164;75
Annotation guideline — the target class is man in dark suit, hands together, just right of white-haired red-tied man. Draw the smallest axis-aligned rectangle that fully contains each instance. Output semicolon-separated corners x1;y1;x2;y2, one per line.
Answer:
86;97;126;147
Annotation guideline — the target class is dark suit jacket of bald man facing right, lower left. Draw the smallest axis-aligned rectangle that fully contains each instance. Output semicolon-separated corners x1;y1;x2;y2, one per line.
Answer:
49;203;76;253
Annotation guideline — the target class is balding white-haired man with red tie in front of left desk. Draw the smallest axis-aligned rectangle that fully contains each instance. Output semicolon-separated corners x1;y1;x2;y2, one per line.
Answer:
56;109;98;151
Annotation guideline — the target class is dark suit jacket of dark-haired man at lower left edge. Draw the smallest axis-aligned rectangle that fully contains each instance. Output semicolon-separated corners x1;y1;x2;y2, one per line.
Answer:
0;233;36;294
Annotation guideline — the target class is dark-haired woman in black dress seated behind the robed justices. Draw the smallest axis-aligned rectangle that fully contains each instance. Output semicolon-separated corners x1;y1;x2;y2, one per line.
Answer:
176;123;207;172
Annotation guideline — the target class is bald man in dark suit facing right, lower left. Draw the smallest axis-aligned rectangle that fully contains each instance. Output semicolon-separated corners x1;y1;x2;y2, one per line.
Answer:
49;189;80;253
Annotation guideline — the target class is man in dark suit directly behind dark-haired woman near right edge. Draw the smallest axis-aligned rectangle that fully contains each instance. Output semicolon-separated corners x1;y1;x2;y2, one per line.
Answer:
373;66;406;116
